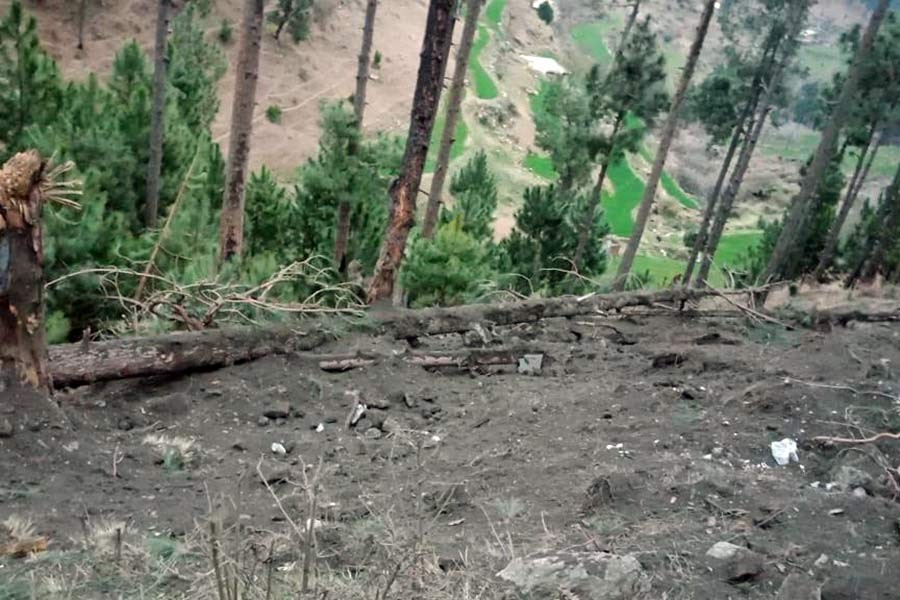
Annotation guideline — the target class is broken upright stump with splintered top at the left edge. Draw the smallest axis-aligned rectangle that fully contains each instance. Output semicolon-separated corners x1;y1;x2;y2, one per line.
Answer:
0;151;51;391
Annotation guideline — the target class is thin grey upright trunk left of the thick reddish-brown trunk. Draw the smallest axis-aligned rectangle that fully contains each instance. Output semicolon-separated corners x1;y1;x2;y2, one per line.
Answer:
144;0;170;228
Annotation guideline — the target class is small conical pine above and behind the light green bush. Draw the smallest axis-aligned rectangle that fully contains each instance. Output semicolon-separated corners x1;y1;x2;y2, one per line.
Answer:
441;150;497;243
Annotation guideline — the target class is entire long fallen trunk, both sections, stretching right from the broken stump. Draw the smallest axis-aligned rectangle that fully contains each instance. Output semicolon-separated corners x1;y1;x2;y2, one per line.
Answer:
50;288;788;387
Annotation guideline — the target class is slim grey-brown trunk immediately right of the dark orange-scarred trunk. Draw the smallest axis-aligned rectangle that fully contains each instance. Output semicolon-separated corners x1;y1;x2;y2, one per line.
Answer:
422;0;483;238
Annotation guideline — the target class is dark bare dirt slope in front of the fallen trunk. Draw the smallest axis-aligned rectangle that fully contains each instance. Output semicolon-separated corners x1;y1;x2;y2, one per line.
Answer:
0;292;900;600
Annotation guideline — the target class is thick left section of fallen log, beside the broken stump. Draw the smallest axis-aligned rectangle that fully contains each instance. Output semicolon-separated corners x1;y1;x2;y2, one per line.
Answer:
50;326;334;388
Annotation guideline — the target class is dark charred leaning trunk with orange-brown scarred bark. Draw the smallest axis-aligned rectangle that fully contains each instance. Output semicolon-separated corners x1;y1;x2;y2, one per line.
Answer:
368;0;455;302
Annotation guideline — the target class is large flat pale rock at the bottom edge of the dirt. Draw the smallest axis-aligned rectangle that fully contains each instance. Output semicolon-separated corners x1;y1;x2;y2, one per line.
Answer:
497;551;650;600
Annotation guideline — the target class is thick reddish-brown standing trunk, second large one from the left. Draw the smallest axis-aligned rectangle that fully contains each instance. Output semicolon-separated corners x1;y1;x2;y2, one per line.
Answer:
219;0;264;262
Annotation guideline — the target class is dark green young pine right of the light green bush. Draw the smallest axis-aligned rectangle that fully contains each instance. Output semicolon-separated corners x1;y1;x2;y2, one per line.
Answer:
500;185;608;294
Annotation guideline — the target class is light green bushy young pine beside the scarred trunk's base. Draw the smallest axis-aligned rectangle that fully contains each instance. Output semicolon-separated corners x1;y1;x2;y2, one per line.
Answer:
401;221;494;308
